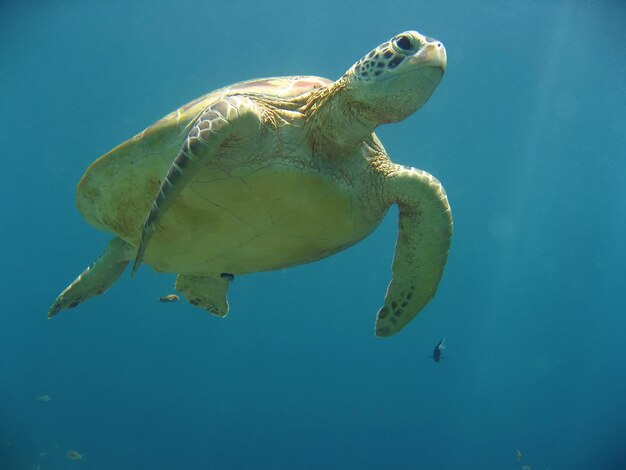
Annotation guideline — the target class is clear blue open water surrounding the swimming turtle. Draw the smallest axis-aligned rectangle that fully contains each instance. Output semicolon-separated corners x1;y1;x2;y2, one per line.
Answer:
0;0;626;470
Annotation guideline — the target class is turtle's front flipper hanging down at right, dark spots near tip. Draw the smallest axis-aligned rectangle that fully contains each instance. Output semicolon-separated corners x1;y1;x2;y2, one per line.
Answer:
376;165;452;336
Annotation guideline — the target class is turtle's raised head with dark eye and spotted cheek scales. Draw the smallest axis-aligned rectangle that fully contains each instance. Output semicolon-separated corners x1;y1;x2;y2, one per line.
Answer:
342;31;446;124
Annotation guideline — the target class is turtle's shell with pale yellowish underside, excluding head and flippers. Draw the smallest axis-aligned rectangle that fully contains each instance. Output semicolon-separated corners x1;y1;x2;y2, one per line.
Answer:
77;76;384;274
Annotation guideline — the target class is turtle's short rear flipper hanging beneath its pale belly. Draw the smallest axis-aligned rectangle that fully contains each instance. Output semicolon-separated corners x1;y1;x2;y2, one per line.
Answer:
175;273;234;317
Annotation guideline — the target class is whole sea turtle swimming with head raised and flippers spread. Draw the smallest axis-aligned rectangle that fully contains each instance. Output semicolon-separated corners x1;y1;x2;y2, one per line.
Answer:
48;31;452;336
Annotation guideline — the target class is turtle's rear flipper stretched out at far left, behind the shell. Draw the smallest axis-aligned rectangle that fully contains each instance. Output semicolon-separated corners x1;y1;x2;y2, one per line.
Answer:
48;237;134;318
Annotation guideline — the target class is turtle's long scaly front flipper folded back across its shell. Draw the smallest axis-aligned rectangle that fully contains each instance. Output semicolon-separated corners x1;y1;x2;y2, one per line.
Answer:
132;96;260;274
